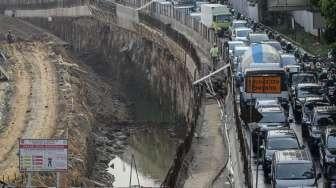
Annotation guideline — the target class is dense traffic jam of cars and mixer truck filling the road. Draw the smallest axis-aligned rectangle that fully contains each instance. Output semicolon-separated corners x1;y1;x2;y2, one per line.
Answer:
223;6;336;188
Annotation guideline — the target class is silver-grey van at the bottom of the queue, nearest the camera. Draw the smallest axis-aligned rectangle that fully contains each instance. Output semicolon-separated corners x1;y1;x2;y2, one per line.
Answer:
271;149;321;188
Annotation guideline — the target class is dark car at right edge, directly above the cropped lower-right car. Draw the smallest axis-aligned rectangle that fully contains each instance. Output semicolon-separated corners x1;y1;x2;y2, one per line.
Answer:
307;106;336;149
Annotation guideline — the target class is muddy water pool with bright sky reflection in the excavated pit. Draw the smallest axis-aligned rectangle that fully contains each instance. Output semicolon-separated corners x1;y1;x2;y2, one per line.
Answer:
107;125;184;187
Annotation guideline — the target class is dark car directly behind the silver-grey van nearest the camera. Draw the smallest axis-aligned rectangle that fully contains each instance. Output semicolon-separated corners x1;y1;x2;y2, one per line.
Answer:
260;129;303;178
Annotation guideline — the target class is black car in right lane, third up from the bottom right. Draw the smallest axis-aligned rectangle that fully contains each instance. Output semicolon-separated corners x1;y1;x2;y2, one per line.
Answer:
301;97;330;137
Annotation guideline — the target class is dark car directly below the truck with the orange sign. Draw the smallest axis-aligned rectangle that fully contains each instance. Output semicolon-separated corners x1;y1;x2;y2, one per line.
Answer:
248;107;289;153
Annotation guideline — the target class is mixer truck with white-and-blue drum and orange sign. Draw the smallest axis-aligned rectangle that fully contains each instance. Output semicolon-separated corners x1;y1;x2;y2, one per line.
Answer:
240;44;289;108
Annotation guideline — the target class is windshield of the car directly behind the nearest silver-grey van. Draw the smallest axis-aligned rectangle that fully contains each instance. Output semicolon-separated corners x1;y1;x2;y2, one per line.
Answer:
267;137;299;150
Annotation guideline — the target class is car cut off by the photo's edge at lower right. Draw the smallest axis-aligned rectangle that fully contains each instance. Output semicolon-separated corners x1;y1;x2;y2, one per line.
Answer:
319;127;336;181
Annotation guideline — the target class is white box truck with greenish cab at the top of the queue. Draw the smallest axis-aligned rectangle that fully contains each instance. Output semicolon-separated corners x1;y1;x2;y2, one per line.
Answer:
201;4;232;33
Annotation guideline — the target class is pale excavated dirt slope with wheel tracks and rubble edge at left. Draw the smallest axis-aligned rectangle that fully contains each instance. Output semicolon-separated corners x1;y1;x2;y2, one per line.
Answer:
0;39;96;186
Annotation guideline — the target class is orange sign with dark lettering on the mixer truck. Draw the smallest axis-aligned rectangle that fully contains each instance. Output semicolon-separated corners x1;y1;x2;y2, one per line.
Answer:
246;76;281;93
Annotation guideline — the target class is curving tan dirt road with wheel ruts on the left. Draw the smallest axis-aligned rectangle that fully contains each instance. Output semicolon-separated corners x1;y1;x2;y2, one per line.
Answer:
0;42;58;177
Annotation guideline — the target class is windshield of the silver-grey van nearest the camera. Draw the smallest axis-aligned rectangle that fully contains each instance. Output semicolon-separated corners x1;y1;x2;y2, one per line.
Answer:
276;163;315;180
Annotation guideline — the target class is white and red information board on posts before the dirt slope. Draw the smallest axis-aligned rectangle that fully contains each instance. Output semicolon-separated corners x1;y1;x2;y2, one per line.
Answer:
19;139;68;172
